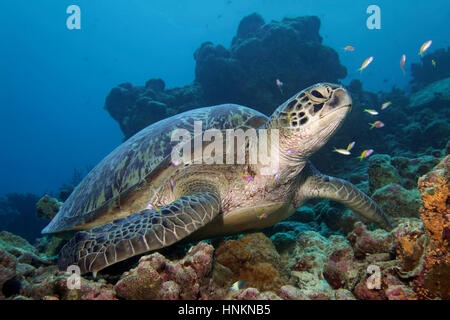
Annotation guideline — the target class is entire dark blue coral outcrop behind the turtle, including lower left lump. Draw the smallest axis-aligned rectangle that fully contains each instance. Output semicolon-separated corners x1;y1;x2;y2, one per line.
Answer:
105;14;347;139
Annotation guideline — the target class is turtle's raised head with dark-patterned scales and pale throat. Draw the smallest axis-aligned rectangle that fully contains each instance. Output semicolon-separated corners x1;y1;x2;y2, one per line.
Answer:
267;83;352;161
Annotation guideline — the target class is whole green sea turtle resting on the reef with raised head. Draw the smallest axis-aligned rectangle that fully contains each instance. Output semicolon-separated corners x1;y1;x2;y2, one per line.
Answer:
42;83;391;274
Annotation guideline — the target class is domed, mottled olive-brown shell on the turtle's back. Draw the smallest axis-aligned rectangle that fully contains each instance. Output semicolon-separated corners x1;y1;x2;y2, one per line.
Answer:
42;104;267;233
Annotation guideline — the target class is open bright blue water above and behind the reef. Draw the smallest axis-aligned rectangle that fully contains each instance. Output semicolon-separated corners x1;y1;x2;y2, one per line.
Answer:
0;0;450;194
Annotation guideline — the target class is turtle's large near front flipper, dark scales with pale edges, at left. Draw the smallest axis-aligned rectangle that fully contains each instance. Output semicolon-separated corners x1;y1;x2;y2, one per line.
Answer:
58;192;221;275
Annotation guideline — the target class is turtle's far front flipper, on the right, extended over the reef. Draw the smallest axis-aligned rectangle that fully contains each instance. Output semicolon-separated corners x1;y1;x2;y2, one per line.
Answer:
296;164;392;230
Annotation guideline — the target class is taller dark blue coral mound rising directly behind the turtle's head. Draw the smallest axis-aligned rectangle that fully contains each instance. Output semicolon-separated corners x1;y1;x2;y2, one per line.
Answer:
194;13;347;114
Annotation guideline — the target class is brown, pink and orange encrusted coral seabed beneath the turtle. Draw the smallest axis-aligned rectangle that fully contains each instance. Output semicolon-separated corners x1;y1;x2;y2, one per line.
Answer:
0;155;450;300
